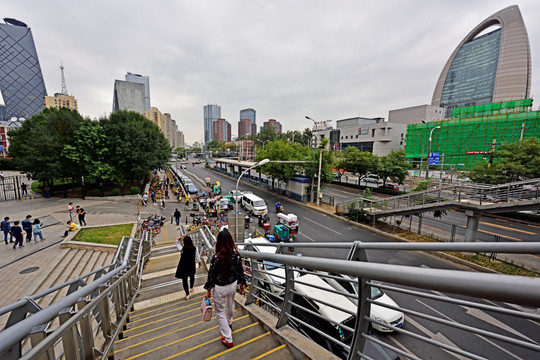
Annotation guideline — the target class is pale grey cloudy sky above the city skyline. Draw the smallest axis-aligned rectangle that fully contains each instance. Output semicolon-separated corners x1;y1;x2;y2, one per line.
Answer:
4;0;540;144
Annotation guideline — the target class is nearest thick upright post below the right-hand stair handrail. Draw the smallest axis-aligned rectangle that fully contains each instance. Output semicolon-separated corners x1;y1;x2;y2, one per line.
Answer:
347;278;371;360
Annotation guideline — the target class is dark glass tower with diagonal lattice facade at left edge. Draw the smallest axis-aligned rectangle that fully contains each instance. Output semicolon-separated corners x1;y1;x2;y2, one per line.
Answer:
0;18;47;120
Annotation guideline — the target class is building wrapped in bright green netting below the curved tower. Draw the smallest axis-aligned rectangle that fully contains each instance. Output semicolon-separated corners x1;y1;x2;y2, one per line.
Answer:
405;98;540;171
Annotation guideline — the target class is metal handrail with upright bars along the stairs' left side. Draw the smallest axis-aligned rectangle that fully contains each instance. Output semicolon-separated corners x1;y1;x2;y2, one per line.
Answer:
0;232;152;359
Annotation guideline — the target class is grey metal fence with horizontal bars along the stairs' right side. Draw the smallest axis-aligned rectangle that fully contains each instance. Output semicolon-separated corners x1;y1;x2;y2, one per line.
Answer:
241;242;540;359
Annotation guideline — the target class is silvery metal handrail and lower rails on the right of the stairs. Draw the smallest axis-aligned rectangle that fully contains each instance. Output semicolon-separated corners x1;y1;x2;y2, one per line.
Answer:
240;242;540;359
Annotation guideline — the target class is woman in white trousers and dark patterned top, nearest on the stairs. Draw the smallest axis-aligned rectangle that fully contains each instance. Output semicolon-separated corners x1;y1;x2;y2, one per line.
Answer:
204;229;246;348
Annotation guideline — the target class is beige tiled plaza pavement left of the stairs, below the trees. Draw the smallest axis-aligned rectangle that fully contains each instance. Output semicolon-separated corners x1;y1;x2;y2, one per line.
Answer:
0;180;184;307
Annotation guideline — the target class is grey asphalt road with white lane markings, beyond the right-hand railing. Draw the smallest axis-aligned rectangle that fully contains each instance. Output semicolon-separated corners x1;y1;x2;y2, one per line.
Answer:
176;164;540;359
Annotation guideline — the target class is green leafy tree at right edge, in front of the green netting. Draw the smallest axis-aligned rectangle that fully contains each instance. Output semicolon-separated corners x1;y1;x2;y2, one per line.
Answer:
469;138;540;184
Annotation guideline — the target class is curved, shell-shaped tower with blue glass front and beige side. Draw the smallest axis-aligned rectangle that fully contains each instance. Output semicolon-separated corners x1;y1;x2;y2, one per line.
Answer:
431;5;531;117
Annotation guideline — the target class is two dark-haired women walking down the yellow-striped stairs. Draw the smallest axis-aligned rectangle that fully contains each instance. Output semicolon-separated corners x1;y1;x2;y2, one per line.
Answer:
175;229;246;348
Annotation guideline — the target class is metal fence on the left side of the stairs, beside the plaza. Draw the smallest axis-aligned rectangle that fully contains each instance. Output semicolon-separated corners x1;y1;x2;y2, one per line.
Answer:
0;232;152;360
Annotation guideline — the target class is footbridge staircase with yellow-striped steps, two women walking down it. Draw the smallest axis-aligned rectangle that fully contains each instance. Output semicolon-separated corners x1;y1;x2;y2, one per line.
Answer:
114;243;304;360
